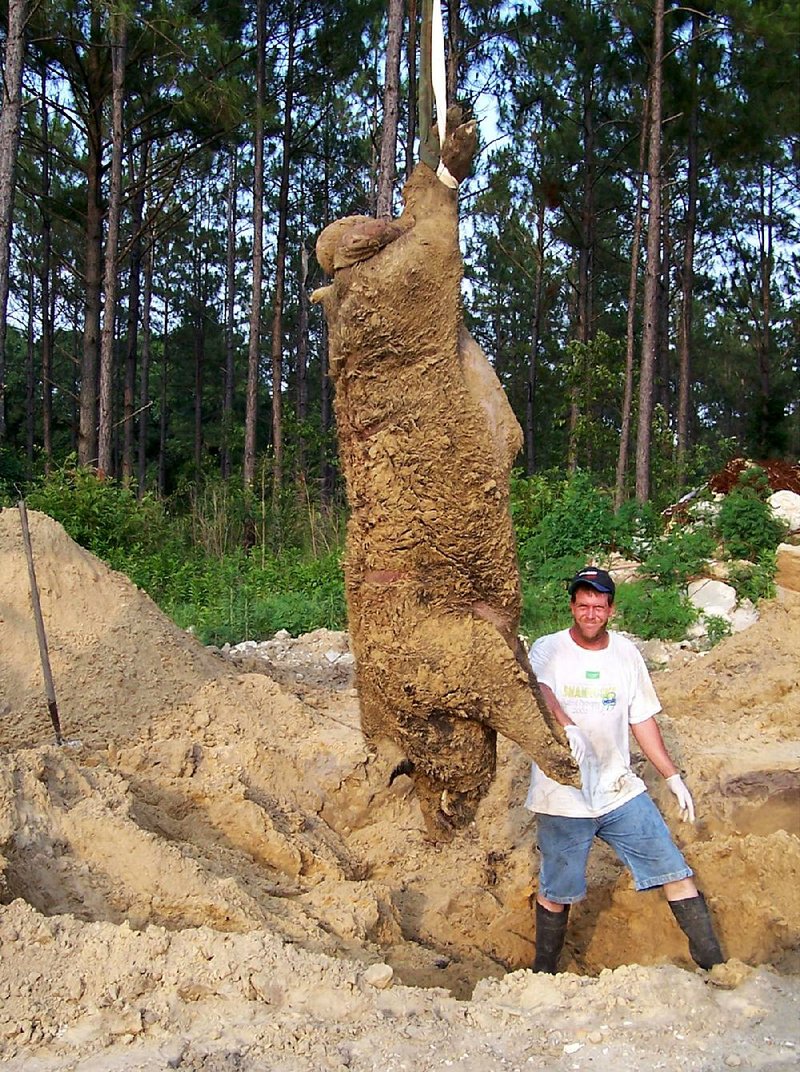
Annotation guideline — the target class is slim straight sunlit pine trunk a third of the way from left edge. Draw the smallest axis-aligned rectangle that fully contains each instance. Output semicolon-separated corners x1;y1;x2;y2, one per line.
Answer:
242;0;266;490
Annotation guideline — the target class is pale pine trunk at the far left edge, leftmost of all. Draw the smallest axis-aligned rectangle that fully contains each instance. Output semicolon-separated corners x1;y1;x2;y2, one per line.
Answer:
0;0;28;443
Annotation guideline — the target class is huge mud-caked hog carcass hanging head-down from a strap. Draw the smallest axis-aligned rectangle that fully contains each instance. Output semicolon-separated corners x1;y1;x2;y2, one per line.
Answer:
314;129;578;837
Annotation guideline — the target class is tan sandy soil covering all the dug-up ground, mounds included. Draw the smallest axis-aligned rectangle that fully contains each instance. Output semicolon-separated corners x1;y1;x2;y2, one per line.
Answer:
0;510;800;1072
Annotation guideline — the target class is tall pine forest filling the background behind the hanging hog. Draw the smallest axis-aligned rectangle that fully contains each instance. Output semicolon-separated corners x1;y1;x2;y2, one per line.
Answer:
0;0;800;638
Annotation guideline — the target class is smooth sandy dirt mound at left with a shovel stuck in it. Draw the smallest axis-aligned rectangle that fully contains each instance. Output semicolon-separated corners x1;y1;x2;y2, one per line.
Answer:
0;509;219;748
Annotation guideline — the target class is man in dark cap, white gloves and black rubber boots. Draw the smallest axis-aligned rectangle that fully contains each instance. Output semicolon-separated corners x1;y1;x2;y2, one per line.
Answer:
525;566;724;974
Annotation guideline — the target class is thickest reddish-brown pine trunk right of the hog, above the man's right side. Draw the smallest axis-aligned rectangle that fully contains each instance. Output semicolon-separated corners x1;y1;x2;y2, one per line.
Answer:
636;0;664;503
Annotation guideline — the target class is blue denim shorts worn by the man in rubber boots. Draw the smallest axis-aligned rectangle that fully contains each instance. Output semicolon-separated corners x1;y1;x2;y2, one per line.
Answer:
536;793;693;905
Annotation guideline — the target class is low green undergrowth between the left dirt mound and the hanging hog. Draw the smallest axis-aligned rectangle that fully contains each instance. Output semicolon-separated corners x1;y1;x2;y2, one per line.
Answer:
20;467;346;644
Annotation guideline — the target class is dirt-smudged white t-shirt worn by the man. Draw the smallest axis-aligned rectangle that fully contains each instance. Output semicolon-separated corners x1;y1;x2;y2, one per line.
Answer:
525;629;661;818
